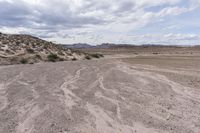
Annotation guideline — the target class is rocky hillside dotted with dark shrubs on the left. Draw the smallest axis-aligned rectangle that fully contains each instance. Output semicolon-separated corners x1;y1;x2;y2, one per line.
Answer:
0;33;89;65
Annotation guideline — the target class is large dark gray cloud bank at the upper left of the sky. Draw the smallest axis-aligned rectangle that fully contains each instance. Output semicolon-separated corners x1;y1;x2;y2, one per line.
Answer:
0;0;106;30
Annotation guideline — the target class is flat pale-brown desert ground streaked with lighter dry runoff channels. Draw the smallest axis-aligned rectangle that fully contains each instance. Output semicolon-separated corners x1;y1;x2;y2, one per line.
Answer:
0;54;200;133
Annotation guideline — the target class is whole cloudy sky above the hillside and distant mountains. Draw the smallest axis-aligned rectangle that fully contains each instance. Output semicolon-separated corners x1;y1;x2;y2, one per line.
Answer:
0;0;200;45
